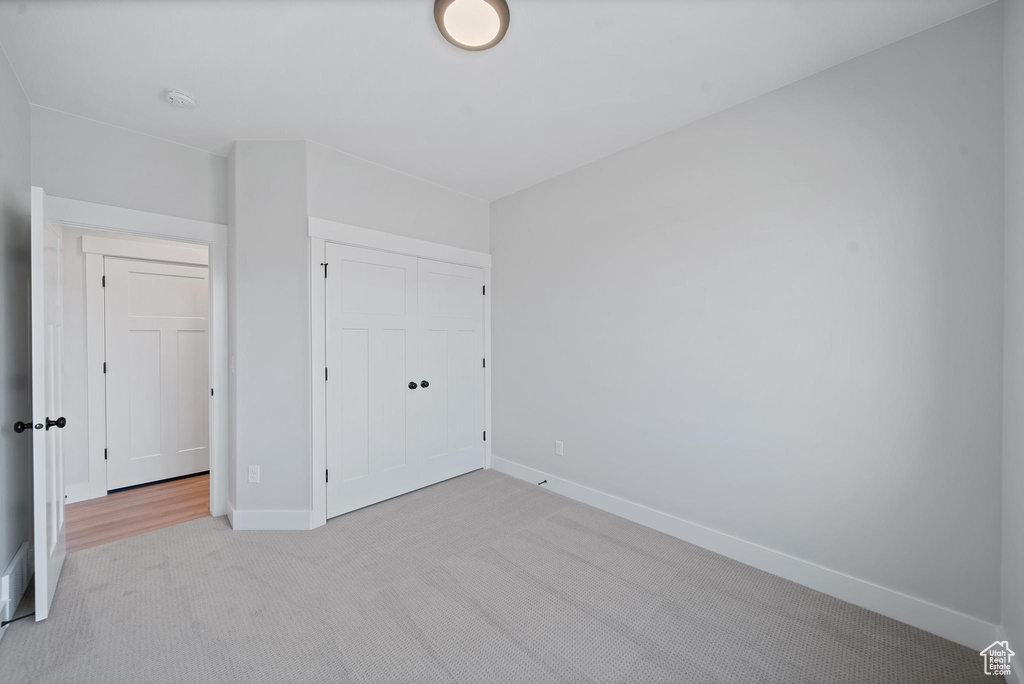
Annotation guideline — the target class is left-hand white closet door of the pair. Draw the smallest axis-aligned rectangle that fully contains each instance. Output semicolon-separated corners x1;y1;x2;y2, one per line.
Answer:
325;243;422;517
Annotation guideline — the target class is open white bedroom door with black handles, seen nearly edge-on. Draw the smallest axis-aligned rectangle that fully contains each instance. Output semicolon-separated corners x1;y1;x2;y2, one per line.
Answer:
31;187;67;622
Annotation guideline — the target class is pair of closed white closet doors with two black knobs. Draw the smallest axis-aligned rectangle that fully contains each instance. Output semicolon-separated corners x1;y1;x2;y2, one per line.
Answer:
322;243;484;517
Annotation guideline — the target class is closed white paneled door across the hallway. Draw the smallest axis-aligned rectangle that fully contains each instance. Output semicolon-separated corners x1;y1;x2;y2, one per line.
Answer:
103;257;210;489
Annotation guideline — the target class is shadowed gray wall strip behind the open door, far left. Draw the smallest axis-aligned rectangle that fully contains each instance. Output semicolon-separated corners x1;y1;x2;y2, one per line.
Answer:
0;40;32;567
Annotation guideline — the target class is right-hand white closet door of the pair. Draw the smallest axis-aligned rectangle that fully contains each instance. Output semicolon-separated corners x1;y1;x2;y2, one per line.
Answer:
417;259;483;485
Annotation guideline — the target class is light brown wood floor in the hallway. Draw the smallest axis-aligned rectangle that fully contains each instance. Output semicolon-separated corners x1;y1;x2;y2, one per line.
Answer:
65;473;210;553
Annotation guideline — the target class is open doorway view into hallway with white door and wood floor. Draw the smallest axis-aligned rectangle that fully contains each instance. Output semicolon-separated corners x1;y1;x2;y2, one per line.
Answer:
60;224;212;552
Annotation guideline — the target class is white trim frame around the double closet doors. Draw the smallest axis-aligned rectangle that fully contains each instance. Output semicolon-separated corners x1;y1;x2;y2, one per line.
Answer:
308;216;492;527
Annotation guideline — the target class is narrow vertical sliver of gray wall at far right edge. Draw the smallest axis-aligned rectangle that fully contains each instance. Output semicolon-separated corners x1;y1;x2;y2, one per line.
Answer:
1002;0;1024;655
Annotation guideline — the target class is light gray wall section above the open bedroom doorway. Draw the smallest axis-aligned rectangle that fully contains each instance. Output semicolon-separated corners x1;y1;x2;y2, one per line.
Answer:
32;106;227;223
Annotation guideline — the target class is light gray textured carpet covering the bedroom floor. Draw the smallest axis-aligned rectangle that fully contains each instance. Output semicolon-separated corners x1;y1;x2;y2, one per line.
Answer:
0;471;994;684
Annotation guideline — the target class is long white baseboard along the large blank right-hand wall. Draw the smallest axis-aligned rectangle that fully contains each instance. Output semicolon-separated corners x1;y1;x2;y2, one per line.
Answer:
490;455;998;650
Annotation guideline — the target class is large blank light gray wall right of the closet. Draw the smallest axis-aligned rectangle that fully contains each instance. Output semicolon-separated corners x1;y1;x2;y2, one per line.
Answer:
492;5;1002;622
